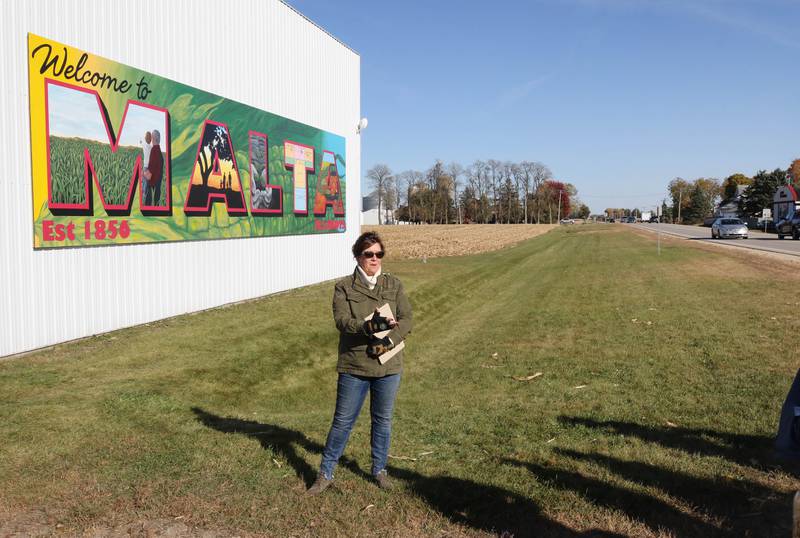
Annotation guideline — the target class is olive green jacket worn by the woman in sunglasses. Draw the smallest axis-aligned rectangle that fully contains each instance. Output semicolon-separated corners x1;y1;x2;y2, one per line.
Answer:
333;269;411;377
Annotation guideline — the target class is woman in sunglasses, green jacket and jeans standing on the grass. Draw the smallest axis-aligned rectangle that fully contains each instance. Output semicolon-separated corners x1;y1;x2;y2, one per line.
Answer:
308;232;411;495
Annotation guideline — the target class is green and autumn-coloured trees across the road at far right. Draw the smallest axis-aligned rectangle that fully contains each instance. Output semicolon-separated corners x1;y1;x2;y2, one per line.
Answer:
605;159;800;224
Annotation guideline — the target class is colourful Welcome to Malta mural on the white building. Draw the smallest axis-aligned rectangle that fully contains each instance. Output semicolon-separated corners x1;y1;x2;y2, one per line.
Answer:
28;34;346;248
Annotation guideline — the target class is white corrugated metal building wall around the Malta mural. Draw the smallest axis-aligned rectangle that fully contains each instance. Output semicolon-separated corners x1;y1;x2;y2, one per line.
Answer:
0;0;361;356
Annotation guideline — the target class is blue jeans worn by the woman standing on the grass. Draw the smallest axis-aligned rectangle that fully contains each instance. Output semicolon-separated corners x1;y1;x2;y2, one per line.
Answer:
319;374;400;480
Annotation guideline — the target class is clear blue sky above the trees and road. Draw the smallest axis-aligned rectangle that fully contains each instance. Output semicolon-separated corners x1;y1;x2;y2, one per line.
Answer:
289;0;800;212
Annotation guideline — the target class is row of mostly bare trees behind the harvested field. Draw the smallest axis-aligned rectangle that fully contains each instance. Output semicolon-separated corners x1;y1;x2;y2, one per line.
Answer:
367;159;589;224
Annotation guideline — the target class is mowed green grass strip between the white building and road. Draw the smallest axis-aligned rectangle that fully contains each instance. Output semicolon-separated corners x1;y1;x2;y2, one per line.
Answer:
0;226;800;536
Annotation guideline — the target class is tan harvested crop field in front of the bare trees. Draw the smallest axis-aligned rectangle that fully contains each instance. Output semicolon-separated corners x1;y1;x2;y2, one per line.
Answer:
361;224;558;255
